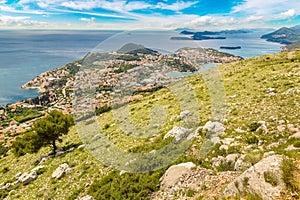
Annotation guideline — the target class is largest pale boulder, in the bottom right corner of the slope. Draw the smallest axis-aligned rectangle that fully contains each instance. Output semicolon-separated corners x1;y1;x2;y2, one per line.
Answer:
223;155;285;200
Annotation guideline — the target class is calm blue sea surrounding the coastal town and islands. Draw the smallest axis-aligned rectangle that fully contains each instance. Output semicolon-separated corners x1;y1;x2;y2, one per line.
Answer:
0;30;282;105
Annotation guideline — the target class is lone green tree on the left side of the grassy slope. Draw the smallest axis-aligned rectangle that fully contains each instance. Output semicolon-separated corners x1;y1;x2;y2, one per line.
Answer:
33;110;74;155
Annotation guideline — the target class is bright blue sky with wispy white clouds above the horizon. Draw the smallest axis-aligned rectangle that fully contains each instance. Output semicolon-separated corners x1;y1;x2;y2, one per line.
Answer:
0;0;300;30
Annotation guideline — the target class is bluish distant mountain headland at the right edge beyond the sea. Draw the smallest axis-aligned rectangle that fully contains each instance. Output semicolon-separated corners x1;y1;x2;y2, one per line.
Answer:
261;25;300;44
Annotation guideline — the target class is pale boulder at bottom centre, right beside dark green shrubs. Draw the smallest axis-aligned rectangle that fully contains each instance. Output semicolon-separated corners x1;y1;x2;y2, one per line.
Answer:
160;162;196;191
